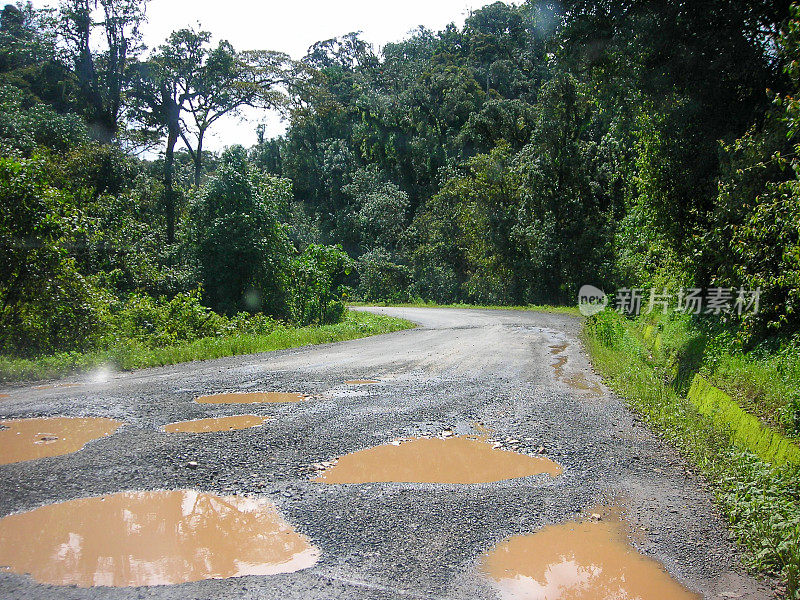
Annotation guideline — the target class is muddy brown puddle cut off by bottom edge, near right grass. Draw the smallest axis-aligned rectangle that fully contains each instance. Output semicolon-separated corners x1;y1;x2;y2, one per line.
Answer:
480;511;701;600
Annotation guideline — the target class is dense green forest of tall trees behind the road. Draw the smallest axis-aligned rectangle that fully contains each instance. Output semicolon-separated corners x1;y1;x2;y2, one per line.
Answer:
0;0;800;357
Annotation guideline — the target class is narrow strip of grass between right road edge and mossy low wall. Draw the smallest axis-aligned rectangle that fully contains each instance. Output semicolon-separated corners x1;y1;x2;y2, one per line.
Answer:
583;311;800;599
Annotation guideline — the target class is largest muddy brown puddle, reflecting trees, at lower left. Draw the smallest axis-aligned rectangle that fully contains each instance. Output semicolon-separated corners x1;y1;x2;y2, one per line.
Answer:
0;490;319;587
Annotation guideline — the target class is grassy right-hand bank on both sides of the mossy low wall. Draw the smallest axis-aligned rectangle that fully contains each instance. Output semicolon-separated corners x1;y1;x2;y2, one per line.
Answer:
584;311;800;598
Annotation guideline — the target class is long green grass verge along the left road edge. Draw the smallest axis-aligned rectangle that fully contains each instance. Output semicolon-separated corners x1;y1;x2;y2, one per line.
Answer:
0;311;414;382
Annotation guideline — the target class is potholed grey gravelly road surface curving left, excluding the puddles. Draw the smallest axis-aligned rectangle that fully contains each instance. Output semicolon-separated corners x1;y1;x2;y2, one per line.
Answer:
0;308;771;600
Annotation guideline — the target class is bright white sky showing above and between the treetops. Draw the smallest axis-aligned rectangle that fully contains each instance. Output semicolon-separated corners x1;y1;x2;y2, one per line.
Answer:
42;0;500;150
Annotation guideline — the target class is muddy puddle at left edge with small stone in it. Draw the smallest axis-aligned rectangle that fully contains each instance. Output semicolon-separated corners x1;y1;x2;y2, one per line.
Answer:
0;417;122;465
